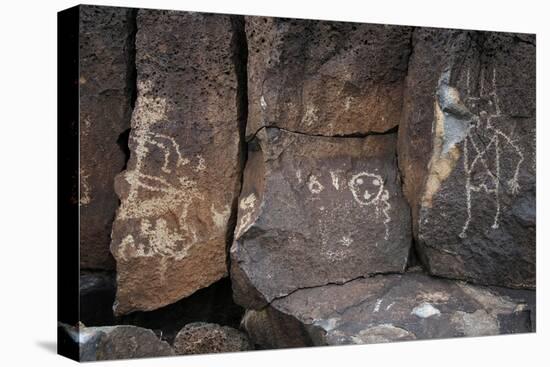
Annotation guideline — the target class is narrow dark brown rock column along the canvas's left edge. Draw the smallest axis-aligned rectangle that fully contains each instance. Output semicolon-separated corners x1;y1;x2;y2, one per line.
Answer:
79;6;134;269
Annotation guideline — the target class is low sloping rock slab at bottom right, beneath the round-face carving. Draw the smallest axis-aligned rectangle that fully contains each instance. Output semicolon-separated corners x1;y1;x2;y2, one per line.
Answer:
243;273;535;348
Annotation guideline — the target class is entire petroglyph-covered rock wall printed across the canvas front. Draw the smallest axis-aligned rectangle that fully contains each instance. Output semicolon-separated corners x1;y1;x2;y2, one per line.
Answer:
75;6;536;360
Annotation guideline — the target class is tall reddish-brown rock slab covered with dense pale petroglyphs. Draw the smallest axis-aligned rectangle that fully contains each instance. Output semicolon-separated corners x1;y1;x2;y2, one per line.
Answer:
111;10;244;314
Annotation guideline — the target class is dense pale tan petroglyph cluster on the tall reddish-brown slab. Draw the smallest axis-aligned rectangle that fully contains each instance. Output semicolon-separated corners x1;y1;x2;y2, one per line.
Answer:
118;83;206;259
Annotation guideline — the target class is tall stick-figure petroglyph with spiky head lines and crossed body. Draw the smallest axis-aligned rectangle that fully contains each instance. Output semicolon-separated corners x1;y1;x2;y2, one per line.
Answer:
459;68;524;238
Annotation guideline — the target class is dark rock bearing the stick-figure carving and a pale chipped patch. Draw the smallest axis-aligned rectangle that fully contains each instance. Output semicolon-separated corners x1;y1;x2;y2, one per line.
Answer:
398;29;536;288
